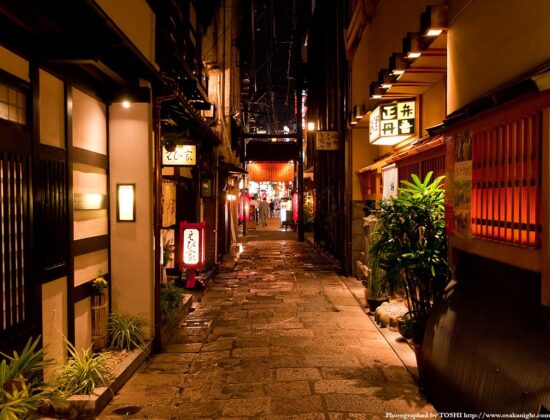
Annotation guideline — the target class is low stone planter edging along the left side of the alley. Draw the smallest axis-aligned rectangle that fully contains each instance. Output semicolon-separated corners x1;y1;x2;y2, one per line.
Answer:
56;342;151;418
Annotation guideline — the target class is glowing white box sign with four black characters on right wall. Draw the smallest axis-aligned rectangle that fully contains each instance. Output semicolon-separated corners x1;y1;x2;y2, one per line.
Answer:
369;101;416;146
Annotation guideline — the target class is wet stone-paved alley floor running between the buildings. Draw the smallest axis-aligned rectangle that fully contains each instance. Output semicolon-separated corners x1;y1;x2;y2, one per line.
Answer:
100;241;436;420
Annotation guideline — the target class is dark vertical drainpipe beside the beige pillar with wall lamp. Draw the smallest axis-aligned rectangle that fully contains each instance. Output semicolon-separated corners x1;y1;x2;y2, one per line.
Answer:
153;94;178;353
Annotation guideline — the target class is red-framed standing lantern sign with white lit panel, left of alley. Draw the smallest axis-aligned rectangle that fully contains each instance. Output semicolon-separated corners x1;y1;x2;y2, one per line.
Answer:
180;222;206;289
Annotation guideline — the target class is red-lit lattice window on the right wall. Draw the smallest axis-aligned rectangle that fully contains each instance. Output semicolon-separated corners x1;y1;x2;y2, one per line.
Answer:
472;113;542;248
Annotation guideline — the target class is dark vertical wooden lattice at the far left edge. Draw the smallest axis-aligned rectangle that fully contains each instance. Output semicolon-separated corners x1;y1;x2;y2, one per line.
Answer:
0;153;29;332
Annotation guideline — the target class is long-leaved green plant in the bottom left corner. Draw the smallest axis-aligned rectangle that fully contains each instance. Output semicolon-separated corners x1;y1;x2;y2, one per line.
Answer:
0;337;61;420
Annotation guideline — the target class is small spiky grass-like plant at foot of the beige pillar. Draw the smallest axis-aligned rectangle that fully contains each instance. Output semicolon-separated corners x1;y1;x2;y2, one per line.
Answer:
109;312;147;351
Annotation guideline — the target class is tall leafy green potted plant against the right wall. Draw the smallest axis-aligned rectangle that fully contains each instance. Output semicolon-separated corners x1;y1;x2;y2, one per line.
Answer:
372;172;449;343
